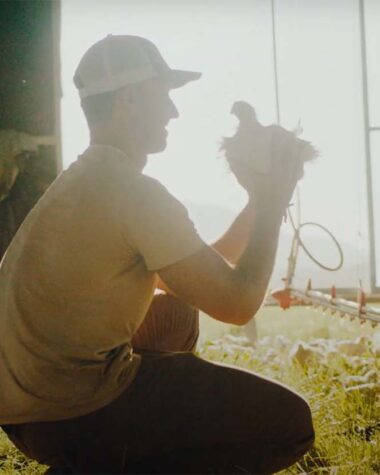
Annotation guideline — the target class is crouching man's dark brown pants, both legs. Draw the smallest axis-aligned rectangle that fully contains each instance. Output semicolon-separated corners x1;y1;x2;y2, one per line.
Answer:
1;296;314;474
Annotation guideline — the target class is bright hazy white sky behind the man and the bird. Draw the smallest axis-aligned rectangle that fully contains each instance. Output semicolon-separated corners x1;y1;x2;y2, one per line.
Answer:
61;0;380;285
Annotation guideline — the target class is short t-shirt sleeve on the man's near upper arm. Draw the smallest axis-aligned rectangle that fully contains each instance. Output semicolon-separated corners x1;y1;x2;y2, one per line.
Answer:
124;175;206;270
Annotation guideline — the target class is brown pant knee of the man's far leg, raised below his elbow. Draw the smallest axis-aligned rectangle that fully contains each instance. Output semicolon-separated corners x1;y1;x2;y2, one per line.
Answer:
132;293;199;353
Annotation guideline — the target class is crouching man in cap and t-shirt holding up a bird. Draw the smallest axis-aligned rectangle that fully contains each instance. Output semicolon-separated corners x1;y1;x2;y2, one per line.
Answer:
0;36;314;473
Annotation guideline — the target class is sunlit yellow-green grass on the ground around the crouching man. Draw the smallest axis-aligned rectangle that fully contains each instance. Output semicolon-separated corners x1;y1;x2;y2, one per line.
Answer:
0;307;380;475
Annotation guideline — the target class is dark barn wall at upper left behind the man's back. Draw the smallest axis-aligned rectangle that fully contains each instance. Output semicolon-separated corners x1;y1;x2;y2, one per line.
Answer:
0;0;61;258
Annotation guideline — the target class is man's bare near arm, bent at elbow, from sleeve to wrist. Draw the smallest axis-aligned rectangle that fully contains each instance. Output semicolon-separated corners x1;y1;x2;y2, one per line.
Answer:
158;198;283;325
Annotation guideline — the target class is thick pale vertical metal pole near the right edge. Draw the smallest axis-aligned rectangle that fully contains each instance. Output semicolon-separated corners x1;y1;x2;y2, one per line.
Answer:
359;0;376;293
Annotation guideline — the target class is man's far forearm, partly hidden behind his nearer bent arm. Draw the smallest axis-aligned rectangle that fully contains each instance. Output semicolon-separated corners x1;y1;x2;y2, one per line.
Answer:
211;200;255;264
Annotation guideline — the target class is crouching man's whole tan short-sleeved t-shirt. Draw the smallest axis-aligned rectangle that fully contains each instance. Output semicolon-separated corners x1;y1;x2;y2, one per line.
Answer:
0;145;205;424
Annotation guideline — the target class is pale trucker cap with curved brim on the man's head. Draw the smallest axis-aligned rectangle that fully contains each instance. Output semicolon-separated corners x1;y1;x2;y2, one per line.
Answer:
73;35;201;99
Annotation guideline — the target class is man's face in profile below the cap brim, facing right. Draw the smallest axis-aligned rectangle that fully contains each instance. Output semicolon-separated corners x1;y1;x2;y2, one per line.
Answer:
120;78;179;155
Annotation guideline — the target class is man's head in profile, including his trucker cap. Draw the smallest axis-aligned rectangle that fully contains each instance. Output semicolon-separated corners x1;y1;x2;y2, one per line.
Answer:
74;35;200;155
